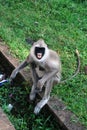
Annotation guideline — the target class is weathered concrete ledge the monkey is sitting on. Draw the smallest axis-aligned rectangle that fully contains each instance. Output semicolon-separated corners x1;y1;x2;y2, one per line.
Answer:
0;43;86;130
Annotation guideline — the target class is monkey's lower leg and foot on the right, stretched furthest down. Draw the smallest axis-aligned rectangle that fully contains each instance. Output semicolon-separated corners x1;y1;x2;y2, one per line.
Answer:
34;79;53;114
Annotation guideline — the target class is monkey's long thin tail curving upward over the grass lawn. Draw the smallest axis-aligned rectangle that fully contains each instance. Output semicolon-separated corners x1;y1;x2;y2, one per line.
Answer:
59;49;80;84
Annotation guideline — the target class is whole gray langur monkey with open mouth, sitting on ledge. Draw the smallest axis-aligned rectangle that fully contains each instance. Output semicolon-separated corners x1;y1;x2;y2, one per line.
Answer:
10;39;80;114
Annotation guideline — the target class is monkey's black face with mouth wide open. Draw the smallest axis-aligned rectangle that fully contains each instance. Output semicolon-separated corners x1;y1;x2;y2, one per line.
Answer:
35;47;45;59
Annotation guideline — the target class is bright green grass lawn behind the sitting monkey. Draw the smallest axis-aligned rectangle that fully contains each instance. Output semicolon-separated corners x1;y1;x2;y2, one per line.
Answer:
0;0;87;126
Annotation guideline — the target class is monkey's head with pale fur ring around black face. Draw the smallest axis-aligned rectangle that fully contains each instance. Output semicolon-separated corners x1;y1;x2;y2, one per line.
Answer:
31;39;49;61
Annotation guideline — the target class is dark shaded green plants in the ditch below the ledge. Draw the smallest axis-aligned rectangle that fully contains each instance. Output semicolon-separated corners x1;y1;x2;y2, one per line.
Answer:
0;84;59;130
